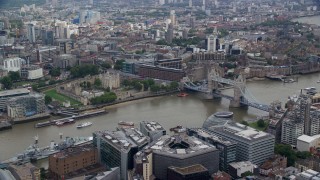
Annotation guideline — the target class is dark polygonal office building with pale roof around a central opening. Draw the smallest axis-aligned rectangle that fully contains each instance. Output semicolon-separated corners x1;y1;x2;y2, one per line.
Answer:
150;131;219;180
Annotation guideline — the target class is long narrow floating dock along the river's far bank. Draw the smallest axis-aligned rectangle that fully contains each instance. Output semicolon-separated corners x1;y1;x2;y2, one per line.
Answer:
35;110;108;128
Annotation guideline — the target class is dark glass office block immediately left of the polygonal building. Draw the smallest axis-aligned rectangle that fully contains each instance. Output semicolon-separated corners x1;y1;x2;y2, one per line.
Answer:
93;128;149;180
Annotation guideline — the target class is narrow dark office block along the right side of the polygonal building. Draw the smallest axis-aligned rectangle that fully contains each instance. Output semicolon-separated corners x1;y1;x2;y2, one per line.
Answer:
187;128;237;172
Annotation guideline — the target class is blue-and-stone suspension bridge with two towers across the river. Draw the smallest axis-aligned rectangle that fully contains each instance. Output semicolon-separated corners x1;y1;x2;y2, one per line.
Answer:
182;67;270;112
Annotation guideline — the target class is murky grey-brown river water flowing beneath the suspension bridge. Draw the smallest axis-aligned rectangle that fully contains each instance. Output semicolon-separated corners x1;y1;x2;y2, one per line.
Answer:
0;73;320;161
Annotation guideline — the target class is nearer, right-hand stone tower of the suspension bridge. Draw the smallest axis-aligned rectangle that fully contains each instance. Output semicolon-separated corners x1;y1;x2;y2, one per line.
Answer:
229;73;246;107
